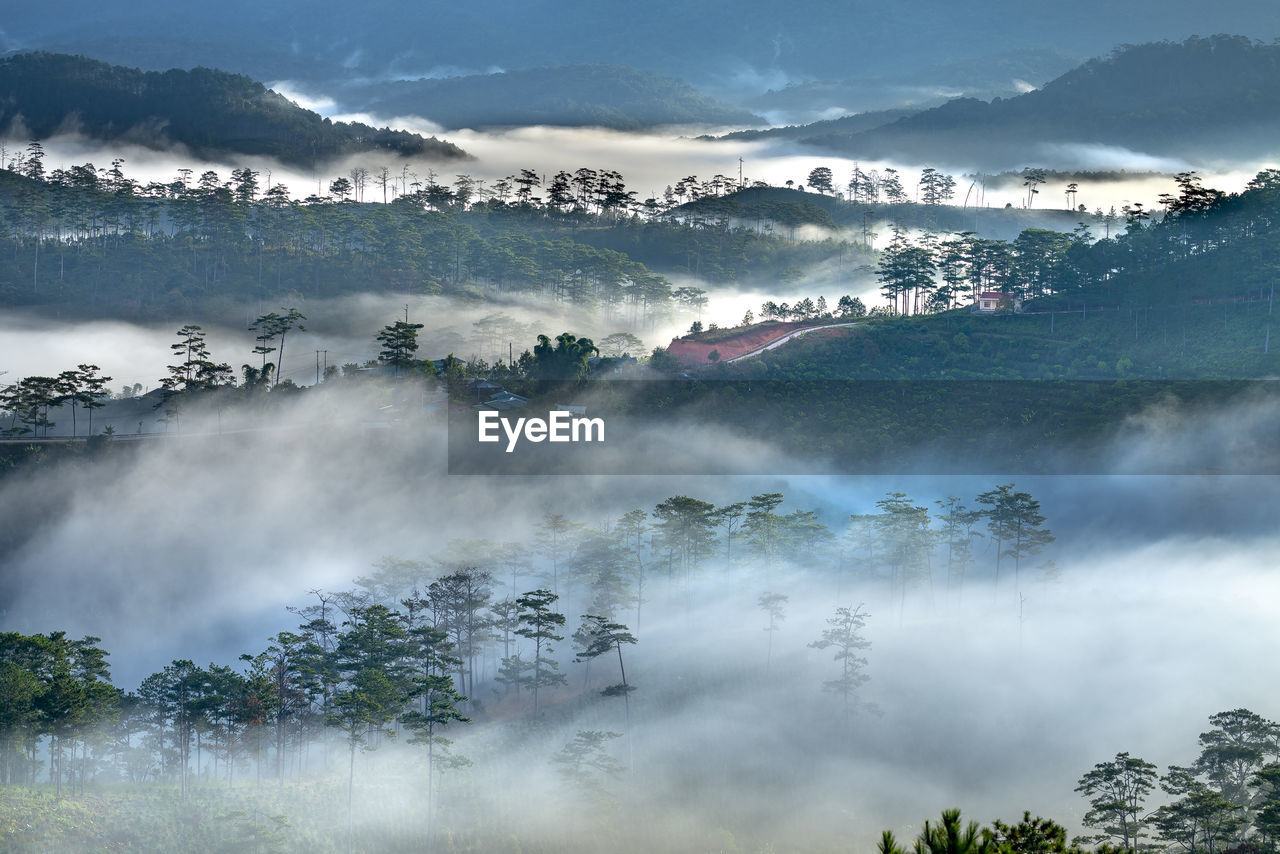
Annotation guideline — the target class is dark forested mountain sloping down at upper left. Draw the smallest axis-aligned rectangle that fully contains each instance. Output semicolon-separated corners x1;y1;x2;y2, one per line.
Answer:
0;52;467;165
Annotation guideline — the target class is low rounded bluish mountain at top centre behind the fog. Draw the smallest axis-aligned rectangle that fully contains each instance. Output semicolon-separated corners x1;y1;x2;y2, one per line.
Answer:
339;64;764;131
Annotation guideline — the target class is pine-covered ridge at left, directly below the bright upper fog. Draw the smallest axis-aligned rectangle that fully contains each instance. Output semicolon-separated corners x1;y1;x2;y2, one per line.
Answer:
0;156;672;320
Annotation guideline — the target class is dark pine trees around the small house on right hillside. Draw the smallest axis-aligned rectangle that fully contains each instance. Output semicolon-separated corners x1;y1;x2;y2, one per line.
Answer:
876;169;1280;314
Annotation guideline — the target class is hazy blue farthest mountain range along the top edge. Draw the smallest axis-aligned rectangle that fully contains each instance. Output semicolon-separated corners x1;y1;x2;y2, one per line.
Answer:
10;0;1280;111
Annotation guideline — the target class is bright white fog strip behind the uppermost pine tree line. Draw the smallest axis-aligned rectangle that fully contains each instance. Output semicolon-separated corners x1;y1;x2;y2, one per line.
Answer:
27;109;1280;220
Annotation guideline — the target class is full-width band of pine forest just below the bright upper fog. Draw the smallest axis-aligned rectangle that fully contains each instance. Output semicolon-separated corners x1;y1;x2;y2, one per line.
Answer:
0;123;1280;328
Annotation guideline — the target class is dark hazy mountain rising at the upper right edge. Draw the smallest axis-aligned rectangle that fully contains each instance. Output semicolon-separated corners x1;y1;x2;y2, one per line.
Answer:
778;36;1280;169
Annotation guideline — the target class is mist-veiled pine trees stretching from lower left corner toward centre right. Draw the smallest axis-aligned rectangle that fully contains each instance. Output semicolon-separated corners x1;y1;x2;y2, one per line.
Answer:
0;483;1057;850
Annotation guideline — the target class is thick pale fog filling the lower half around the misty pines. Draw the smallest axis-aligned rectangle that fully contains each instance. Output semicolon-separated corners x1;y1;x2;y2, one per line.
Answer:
0;358;1280;850
